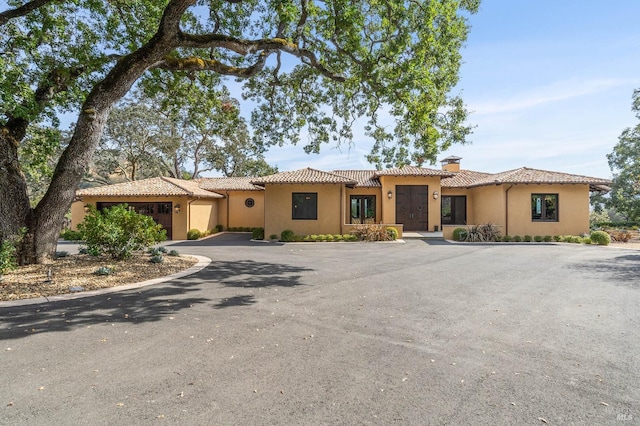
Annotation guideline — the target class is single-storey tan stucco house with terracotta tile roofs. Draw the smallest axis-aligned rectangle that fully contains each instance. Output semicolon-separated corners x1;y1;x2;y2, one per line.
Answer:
72;157;611;240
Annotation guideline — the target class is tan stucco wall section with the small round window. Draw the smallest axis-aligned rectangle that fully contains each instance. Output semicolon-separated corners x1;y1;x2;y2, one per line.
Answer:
216;191;264;229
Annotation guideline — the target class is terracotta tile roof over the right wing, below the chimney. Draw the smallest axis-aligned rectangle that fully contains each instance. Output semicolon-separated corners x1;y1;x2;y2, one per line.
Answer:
442;167;611;190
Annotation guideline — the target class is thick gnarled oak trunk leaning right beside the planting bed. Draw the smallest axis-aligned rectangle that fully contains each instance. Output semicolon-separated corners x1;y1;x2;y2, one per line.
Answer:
5;0;194;264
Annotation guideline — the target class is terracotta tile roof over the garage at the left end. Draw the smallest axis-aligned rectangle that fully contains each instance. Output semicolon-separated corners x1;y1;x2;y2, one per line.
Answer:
76;177;223;198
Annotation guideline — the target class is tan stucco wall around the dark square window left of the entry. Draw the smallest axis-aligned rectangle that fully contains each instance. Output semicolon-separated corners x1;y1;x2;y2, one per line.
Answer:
264;184;345;237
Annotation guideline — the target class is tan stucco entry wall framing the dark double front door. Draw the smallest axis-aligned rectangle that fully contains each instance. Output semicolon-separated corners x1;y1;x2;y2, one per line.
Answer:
380;176;442;231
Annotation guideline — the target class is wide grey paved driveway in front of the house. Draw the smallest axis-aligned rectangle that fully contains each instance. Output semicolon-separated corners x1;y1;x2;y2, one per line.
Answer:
0;235;640;425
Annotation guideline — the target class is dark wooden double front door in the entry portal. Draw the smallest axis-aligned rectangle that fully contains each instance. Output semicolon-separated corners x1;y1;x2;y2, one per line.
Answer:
396;185;429;231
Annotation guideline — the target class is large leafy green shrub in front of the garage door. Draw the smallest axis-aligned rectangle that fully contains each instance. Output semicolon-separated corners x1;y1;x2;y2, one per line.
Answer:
78;204;167;259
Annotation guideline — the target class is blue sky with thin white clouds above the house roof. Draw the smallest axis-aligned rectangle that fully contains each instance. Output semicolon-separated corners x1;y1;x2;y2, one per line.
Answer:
254;0;640;178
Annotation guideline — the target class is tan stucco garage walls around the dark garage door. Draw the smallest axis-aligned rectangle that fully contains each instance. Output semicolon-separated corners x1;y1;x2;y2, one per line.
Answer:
71;196;218;240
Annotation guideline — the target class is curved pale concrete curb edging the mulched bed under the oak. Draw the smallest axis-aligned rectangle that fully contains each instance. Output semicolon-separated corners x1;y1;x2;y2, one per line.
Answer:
0;254;211;308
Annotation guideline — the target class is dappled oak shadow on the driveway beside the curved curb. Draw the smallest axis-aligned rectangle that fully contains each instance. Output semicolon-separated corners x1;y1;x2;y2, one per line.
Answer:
0;260;311;340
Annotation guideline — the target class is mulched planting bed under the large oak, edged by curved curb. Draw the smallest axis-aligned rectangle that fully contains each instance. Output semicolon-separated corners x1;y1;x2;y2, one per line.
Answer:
0;253;197;301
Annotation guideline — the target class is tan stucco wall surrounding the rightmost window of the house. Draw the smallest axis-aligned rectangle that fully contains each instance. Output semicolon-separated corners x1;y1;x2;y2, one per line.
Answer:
507;184;589;236
